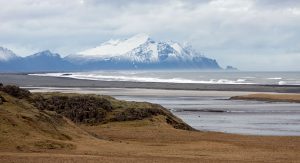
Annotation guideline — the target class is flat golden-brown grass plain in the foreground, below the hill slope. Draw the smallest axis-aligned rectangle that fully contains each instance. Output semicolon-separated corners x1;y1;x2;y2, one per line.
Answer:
0;117;300;163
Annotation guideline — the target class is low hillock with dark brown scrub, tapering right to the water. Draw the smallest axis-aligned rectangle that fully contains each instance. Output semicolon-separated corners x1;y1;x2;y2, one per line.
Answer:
31;93;193;130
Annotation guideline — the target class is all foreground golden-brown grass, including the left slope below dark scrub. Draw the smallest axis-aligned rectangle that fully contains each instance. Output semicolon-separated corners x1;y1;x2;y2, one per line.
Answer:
0;91;300;163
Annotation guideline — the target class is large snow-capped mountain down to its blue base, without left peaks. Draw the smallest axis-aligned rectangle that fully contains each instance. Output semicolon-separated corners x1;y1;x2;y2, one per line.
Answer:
66;34;220;69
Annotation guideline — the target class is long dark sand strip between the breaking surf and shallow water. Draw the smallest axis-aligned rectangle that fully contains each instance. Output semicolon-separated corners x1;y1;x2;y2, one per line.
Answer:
0;73;300;93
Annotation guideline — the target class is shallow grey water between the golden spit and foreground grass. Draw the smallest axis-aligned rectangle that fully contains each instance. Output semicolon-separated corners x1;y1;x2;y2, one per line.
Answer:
115;93;300;136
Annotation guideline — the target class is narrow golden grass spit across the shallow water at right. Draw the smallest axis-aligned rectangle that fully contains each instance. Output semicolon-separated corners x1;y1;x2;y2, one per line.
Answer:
231;94;300;103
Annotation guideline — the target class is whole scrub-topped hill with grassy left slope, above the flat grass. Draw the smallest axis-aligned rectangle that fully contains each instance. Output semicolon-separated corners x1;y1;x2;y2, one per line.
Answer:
0;86;193;151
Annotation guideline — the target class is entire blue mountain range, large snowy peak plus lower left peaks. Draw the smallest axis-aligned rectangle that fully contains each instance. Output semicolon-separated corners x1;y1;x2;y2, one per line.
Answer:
0;34;221;72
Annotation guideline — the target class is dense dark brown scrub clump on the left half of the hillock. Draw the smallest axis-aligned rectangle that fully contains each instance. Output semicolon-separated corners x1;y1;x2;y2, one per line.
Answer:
33;95;112;124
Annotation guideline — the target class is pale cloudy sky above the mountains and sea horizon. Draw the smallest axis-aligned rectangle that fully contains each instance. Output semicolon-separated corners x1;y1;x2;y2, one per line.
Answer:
0;0;300;70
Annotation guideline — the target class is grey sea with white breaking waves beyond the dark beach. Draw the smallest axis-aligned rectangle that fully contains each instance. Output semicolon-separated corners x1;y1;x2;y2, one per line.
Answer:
30;70;300;85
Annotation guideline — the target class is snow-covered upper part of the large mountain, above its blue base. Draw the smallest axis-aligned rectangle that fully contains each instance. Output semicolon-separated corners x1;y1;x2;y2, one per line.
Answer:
66;34;213;64
